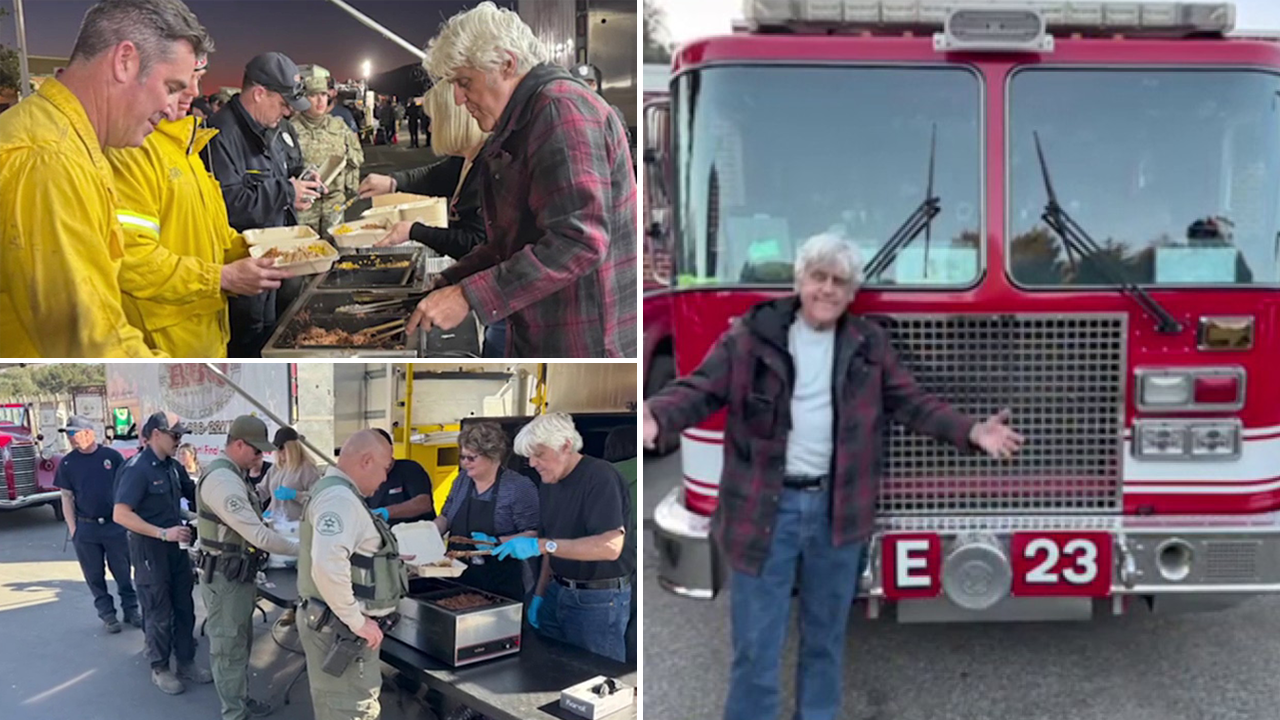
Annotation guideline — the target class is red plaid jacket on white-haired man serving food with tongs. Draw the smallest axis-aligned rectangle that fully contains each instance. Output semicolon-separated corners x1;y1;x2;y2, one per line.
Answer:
444;64;639;357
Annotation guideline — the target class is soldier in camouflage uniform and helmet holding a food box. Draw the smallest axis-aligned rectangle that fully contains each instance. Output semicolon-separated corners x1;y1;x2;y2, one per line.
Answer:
293;65;365;234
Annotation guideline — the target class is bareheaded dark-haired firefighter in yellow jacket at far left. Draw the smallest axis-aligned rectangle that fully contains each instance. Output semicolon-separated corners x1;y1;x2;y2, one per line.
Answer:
0;0;212;357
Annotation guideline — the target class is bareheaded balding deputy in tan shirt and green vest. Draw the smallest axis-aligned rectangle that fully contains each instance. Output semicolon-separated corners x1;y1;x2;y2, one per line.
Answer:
298;430;408;720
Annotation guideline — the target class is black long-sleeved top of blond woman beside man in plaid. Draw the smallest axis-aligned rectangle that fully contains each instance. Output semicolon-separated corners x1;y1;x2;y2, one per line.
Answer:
392;156;485;260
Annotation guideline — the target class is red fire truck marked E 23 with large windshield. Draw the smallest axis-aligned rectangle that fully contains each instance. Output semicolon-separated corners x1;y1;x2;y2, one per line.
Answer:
646;0;1280;621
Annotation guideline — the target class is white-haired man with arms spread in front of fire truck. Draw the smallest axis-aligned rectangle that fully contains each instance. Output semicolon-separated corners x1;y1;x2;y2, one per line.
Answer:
644;234;1021;720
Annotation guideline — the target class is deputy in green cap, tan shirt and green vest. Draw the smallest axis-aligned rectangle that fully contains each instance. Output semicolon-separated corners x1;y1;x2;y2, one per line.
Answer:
196;415;298;720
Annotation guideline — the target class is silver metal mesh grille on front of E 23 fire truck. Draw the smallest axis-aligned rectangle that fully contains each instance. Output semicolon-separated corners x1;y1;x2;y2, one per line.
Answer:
877;315;1126;516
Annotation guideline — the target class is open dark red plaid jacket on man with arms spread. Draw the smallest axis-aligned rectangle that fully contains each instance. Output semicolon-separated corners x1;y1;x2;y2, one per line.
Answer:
648;296;974;575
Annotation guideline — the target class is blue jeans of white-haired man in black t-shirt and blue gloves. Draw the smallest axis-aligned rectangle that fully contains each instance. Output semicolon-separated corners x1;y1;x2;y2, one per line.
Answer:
538;579;631;662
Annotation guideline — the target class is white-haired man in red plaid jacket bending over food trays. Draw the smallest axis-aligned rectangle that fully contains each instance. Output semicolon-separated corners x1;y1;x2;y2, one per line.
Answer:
407;3;637;357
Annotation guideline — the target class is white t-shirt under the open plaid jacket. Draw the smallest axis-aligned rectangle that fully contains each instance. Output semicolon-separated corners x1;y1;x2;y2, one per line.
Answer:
786;316;836;475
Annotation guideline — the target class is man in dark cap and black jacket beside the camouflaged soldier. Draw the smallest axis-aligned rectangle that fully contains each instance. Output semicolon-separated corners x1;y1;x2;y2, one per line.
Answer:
205;53;323;357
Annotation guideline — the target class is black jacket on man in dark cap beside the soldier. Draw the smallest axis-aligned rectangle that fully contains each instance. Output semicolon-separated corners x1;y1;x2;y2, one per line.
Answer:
205;95;297;232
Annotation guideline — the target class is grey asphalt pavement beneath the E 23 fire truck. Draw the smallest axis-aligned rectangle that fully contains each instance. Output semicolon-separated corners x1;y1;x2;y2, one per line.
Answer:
641;455;1280;720
